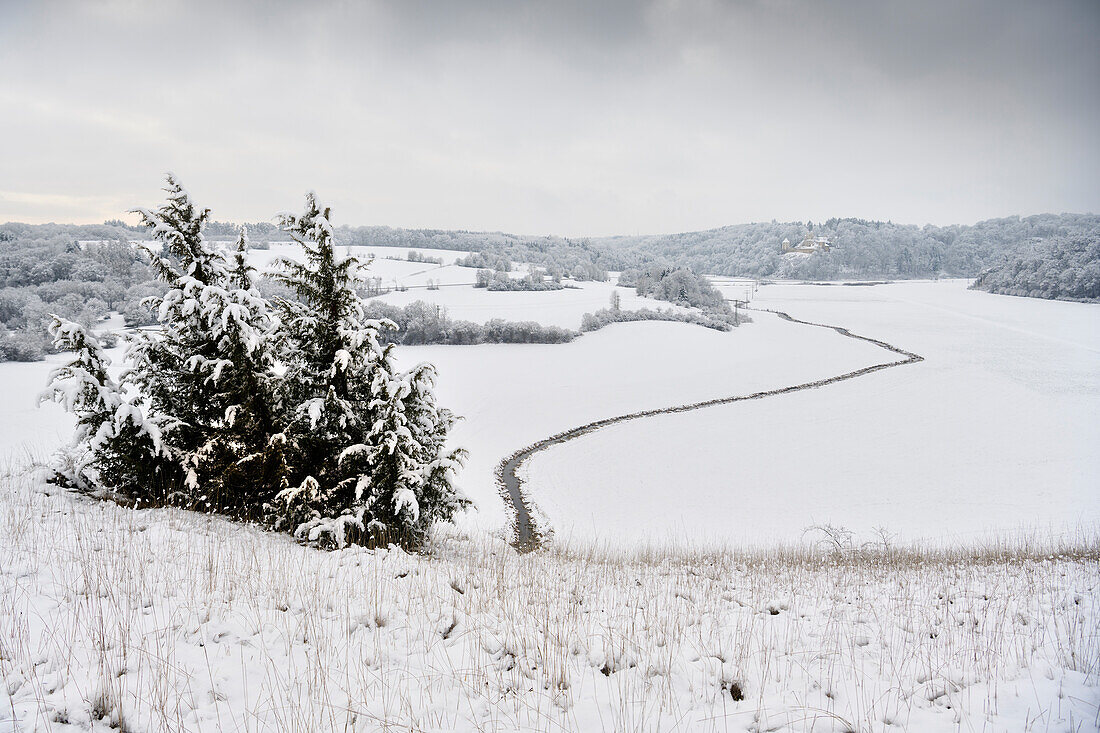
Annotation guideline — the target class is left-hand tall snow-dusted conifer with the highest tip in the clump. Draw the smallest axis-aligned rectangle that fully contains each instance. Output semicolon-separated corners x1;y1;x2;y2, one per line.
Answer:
125;175;281;515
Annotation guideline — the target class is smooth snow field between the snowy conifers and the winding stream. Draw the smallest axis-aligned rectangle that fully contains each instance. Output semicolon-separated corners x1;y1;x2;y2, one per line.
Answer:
397;310;880;526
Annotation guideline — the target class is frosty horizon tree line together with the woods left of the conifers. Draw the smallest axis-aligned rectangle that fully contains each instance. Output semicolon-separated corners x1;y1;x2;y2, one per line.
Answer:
0;208;1100;361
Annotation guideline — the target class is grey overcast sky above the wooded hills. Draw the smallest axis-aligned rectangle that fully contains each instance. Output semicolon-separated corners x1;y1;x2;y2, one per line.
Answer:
0;0;1100;236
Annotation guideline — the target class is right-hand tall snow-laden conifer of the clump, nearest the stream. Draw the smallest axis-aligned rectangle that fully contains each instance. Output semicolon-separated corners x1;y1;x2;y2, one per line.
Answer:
274;194;469;546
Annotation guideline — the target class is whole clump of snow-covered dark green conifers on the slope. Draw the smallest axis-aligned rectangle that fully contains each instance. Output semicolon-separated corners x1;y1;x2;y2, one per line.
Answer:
42;175;470;548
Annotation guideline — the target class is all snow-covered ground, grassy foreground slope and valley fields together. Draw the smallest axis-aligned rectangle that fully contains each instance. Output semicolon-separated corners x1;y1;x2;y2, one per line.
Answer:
0;270;1100;733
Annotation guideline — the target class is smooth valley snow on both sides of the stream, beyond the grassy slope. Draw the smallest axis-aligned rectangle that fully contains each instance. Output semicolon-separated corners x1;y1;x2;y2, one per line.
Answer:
10;279;1100;545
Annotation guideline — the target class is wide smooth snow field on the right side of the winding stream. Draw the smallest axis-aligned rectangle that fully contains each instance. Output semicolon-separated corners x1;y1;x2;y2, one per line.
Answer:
526;281;1100;544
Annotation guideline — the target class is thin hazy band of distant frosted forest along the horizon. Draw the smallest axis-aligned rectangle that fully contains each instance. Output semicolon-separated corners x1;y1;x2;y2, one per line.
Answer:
0;214;1100;280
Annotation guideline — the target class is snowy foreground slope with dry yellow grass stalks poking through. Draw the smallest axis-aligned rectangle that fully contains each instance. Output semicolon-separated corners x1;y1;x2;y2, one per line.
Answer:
0;468;1100;733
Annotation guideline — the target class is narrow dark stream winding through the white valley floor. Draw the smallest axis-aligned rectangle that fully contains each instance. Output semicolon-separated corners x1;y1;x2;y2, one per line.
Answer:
496;308;924;551
